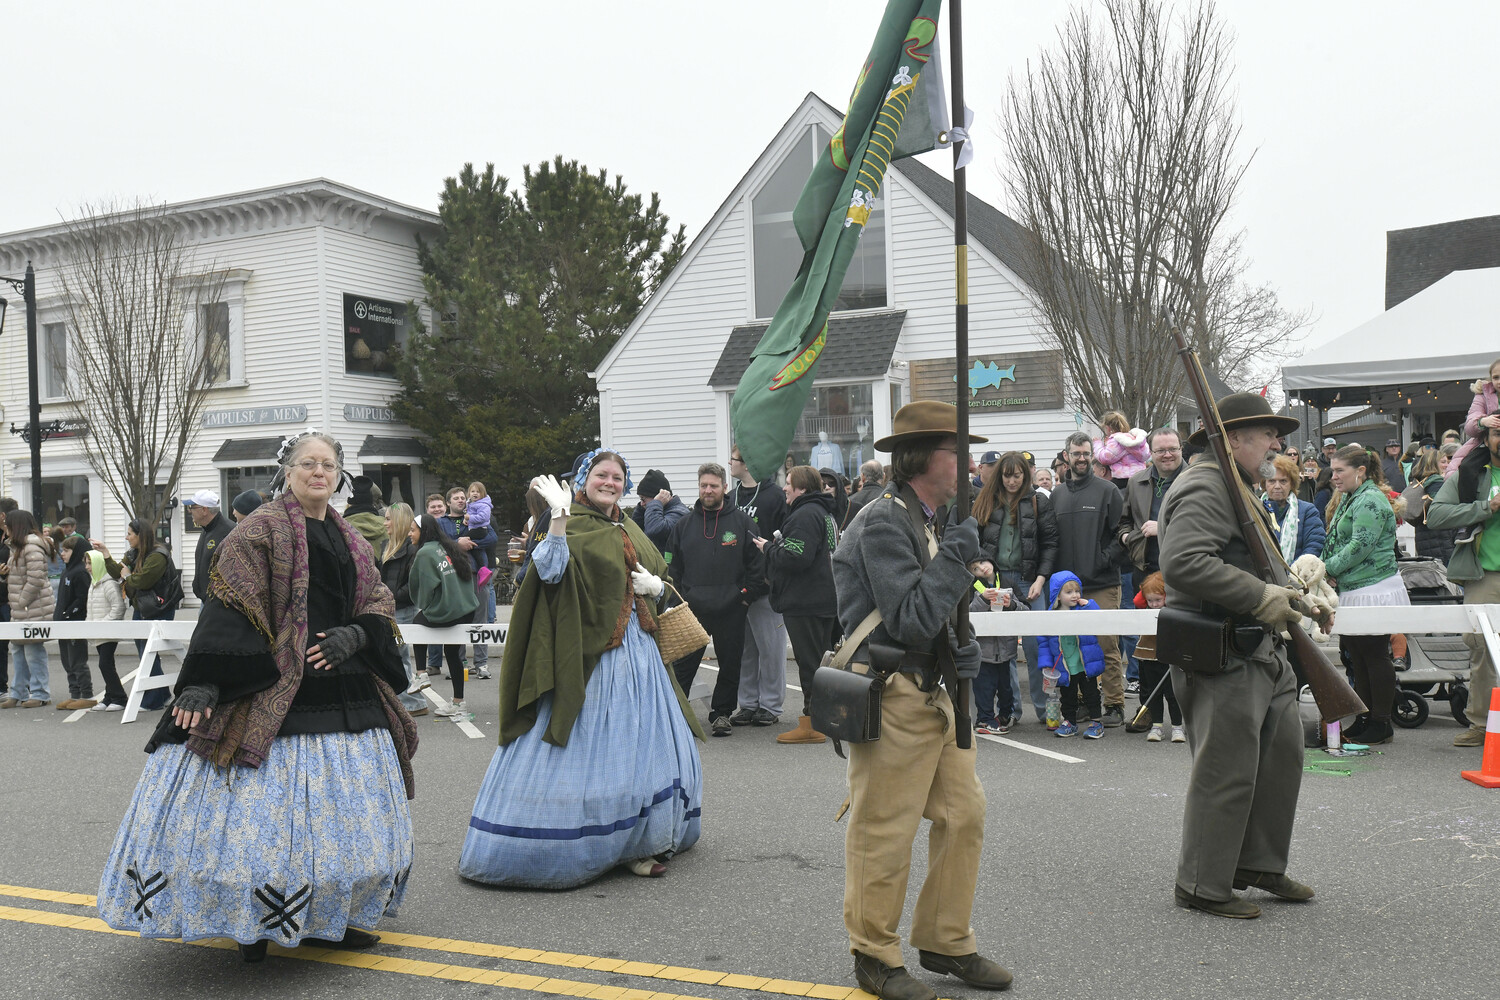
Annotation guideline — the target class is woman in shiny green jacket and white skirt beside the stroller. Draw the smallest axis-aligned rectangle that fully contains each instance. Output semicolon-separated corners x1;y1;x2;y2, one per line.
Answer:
1323;445;1412;744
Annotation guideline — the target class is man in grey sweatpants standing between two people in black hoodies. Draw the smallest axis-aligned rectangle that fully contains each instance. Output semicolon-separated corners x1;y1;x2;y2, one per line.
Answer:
729;445;786;726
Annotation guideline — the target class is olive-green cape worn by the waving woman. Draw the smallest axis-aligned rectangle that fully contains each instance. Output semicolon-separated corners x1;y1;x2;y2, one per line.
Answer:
500;504;704;747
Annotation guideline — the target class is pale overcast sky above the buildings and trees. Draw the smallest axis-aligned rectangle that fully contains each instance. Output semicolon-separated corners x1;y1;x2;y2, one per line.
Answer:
0;0;1500;359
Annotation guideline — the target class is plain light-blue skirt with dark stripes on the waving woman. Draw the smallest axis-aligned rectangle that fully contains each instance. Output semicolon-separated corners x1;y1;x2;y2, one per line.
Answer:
459;615;704;889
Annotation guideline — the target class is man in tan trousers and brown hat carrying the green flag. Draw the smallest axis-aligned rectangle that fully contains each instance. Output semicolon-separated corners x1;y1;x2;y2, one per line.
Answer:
834;400;1011;1000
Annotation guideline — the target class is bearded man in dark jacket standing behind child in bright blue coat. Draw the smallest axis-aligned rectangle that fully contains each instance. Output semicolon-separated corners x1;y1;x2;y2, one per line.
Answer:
1052;432;1125;727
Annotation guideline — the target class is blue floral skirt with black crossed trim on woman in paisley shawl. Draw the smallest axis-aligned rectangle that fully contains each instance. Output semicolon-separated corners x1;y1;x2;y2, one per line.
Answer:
99;729;413;948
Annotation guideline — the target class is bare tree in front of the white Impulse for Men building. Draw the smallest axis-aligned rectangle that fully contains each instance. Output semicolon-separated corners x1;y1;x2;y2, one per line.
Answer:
51;202;230;523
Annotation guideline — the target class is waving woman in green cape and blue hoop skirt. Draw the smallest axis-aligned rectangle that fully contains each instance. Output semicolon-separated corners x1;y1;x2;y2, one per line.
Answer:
459;448;702;889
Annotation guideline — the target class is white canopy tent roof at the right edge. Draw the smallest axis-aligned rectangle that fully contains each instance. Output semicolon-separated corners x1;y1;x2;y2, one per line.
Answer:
1281;267;1500;393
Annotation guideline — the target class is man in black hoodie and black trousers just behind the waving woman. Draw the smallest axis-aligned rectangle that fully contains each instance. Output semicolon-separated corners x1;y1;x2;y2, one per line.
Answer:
662;462;774;736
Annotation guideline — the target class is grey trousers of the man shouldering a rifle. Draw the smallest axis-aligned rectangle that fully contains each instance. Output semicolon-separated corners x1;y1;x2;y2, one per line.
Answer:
1172;637;1302;900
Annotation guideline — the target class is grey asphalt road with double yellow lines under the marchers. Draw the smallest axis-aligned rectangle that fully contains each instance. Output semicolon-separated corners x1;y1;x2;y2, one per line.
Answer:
0;652;1500;1000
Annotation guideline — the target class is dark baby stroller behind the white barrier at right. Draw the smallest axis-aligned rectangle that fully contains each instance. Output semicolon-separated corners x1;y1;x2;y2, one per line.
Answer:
1391;556;1469;729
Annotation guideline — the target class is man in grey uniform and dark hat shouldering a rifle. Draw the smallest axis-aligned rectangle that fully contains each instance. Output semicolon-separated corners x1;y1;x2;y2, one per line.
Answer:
1158;393;1313;918
